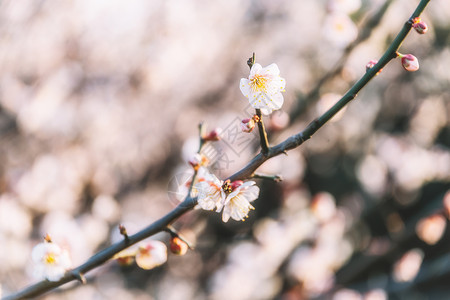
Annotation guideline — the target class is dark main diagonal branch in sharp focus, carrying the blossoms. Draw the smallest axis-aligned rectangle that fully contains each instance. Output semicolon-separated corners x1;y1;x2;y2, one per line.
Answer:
3;0;430;300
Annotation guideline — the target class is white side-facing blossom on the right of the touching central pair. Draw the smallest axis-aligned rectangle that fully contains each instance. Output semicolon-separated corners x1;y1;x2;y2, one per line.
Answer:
217;181;259;222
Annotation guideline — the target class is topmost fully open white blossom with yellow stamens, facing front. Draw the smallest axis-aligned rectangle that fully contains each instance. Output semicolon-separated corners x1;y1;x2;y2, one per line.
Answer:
240;63;286;115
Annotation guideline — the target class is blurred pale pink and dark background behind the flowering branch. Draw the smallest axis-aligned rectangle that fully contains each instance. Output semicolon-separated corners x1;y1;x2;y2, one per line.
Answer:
0;0;450;300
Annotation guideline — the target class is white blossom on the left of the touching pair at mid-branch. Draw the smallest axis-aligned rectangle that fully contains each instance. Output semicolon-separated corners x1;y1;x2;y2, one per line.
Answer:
195;174;226;212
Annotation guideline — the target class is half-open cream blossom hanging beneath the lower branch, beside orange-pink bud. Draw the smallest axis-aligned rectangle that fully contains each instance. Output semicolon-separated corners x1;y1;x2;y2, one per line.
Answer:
135;240;167;270
